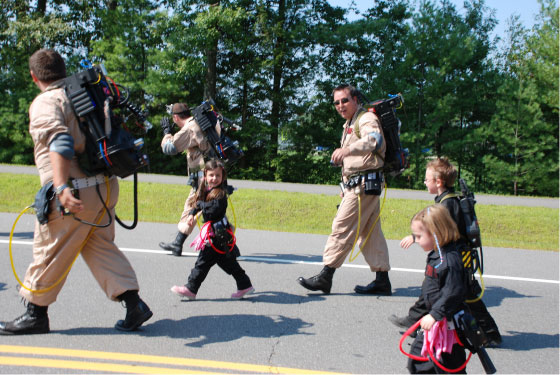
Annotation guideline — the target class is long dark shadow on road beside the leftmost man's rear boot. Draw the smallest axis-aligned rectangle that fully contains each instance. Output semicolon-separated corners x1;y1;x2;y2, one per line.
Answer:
139;314;313;348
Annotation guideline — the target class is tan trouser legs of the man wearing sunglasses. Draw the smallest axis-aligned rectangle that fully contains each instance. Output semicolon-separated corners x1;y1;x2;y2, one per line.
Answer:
323;189;391;272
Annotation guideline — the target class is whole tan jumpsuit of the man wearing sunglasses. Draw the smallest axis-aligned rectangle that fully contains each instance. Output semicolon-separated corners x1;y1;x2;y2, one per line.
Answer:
323;109;390;272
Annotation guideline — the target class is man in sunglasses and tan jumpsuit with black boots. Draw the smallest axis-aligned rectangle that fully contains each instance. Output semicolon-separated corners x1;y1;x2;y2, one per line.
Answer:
297;85;392;295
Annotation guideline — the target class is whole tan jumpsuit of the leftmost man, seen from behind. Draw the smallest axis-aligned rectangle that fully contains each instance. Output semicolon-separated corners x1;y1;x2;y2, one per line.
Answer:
20;81;139;306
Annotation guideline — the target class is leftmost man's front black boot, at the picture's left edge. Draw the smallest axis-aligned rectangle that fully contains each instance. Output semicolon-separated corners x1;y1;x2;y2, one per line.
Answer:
0;302;50;335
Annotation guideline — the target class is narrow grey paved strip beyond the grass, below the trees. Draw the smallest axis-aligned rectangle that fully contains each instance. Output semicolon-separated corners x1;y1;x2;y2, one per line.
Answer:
0;164;559;208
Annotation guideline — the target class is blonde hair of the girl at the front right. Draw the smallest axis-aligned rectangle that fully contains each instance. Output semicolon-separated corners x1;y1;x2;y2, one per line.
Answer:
411;203;460;246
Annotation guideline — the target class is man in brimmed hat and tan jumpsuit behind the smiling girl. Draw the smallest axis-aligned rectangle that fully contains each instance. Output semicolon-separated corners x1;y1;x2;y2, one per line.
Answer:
159;103;220;256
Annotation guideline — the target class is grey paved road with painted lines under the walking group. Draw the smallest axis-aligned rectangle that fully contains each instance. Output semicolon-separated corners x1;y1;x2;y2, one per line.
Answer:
0;213;560;374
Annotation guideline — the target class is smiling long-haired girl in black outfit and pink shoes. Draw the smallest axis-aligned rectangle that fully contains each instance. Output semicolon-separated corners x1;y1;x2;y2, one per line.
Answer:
171;159;254;300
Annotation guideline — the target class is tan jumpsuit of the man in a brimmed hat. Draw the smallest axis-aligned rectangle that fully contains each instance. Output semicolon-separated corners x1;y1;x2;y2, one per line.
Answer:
161;117;220;236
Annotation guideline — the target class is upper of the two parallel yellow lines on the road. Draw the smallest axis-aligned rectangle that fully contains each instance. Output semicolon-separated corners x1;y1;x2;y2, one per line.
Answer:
0;345;342;374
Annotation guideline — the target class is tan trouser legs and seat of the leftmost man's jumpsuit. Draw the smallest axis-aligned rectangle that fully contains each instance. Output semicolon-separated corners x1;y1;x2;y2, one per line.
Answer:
20;178;139;306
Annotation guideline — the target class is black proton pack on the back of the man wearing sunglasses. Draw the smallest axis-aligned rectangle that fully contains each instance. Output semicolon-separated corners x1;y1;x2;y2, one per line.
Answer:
354;94;408;177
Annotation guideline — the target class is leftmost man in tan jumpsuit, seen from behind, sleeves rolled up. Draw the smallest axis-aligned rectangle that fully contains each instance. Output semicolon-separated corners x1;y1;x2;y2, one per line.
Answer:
0;49;152;335
